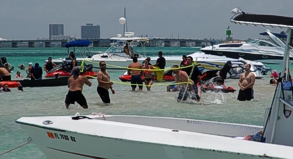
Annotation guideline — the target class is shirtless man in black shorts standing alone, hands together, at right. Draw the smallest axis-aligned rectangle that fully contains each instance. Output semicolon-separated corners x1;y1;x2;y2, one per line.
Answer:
237;64;255;101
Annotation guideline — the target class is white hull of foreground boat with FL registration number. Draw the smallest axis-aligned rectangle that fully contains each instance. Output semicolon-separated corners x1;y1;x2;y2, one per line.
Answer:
17;116;293;159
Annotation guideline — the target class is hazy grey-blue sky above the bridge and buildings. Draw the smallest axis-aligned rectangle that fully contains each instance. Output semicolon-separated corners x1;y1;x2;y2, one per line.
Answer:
0;0;293;40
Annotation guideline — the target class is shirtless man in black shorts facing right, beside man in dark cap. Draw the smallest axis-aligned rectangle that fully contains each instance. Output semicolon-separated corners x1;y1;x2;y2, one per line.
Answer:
97;61;115;103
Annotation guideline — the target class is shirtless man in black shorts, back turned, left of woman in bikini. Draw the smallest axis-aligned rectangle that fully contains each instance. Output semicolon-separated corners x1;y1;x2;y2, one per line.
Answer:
128;57;143;91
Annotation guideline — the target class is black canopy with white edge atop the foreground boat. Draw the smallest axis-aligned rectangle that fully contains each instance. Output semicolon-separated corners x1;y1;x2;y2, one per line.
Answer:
230;8;293;29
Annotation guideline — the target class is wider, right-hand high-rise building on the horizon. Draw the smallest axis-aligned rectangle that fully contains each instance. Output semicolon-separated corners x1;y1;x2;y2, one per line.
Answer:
81;23;100;39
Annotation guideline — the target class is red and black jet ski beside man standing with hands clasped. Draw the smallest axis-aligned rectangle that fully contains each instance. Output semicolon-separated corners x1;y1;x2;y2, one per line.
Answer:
201;76;236;93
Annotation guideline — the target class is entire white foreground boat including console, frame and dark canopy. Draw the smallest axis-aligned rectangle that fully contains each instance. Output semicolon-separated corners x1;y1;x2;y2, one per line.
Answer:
16;9;293;159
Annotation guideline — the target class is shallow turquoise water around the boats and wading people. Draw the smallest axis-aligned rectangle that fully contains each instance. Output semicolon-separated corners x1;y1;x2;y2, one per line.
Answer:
0;48;281;159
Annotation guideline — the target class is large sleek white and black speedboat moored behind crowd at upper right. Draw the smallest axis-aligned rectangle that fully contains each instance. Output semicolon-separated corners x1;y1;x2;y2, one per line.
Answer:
201;31;293;64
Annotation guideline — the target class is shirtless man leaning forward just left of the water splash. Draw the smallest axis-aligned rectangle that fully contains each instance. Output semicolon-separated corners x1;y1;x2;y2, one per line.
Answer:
172;65;193;102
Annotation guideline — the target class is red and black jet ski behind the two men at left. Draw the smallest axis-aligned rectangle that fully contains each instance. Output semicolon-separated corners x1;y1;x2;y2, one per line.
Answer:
45;63;97;78
